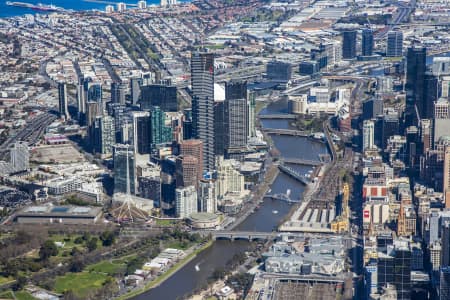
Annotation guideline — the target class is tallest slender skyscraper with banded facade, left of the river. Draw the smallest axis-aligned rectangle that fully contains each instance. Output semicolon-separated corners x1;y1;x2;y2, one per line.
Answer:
191;52;215;171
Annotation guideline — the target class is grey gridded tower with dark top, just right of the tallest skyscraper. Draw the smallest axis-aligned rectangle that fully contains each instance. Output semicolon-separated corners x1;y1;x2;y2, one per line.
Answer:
224;82;249;150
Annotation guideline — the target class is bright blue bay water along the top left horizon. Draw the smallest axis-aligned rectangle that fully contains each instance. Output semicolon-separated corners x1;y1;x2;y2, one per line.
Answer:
0;0;160;18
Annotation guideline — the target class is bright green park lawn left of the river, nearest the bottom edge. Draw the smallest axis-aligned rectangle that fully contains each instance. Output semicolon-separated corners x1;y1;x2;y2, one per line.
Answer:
55;272;108;298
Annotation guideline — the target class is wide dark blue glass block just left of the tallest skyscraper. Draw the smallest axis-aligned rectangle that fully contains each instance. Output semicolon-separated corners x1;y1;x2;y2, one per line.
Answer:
140;84;178;112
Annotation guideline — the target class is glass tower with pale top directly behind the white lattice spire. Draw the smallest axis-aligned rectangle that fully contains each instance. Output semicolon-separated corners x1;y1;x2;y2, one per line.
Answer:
114;144;136;195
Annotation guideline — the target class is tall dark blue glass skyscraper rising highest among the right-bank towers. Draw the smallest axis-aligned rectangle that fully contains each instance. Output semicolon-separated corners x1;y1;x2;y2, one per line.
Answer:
405;47;427;120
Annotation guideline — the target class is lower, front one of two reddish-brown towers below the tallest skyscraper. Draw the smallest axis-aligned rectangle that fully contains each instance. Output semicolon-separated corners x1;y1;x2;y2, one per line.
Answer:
175;155;202;189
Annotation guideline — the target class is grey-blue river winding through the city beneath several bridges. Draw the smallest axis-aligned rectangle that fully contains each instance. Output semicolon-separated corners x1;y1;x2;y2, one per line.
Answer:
134;101;327;300
